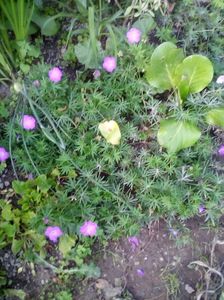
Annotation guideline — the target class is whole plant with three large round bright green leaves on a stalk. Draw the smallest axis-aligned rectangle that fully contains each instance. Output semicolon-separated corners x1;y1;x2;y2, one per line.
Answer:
146;42;213;153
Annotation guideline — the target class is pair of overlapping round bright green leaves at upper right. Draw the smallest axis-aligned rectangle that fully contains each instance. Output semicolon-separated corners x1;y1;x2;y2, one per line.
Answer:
146;42;213;100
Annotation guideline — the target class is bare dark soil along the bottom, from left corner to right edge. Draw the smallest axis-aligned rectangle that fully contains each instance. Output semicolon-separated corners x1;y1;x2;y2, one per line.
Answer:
0;217;224;300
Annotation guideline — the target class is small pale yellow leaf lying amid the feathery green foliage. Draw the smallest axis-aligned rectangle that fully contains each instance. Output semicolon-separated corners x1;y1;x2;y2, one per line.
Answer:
99;120;121;145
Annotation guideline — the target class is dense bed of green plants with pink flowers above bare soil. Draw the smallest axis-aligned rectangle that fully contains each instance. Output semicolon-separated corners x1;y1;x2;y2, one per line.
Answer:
0;0;224;299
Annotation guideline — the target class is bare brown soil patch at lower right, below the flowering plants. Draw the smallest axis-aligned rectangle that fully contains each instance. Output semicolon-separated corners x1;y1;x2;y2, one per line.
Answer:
74;217;224;300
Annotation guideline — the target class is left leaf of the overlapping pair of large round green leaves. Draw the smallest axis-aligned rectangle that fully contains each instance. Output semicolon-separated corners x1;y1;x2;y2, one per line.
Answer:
146;42;184;91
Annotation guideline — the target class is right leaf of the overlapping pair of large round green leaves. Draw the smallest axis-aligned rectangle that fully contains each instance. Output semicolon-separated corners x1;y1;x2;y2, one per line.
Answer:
176;55;213;98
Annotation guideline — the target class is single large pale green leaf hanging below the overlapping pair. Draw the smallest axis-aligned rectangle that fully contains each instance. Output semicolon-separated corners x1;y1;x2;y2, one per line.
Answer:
157;119;201;153
